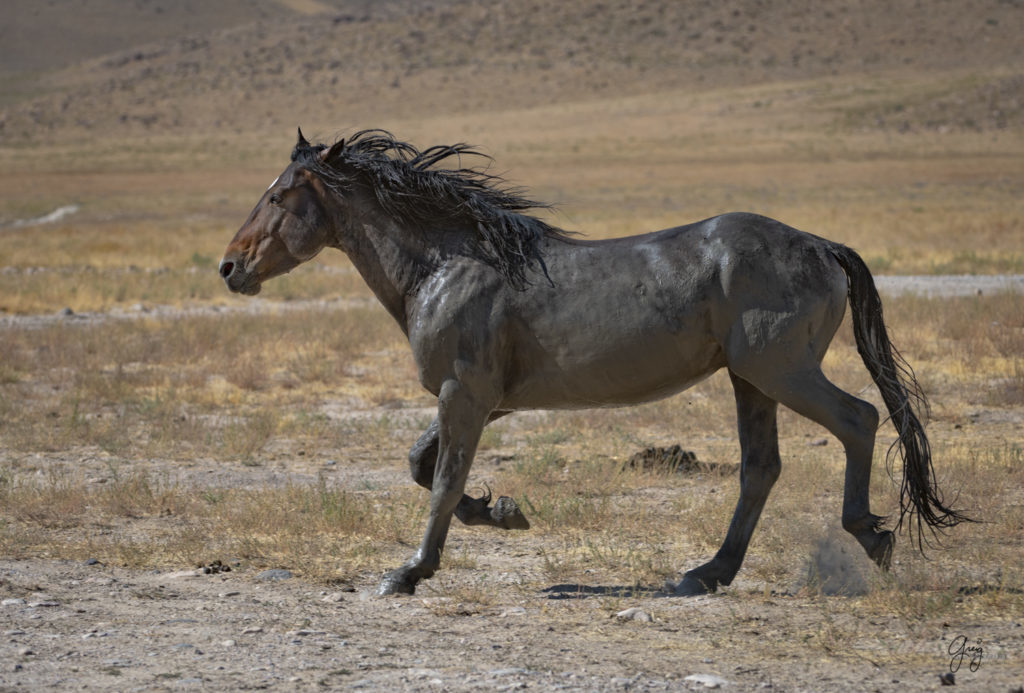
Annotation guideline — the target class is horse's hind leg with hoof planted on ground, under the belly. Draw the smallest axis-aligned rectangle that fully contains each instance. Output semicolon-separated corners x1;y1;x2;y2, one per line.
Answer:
673;372;781;596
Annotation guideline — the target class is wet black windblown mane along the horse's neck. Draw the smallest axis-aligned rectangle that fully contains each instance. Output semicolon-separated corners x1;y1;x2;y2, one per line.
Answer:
292;130;567;289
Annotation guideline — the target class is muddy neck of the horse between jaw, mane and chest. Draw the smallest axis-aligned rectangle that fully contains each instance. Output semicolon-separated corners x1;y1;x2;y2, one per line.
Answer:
341;210;437;334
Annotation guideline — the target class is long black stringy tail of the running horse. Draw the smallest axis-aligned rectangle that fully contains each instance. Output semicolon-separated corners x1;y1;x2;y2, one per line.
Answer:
831;245;971;549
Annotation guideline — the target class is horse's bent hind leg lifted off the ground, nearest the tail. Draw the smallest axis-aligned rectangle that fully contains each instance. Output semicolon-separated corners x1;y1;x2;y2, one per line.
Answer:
741;365;895;569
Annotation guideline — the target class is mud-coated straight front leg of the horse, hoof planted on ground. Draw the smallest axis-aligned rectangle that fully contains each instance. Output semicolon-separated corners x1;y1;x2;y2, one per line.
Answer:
377;380;490;595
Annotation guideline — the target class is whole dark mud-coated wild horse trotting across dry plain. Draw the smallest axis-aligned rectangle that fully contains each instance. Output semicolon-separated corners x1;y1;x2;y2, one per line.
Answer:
220;130;966;595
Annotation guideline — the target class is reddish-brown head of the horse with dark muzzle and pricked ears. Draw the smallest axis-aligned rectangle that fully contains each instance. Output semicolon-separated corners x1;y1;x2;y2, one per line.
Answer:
220;129;343;296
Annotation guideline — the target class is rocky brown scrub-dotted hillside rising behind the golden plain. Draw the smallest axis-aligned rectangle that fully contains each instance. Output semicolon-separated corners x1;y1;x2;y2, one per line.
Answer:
0;0;1024;144
